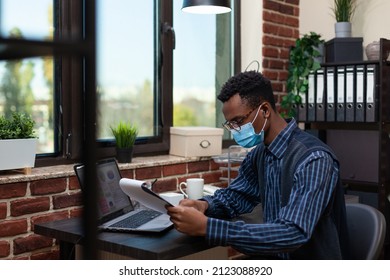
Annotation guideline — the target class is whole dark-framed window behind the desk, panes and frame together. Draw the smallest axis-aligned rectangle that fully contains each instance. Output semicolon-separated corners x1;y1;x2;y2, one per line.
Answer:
0;0;238;166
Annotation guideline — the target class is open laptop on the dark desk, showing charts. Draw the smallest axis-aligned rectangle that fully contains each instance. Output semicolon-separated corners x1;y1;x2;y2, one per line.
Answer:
74;158;173;233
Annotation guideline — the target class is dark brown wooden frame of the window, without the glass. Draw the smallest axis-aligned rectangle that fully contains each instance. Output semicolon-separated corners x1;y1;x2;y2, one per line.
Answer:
36;0;241;167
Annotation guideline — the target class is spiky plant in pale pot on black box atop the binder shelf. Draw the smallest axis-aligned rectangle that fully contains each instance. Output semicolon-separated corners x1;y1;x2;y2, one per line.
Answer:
332;0;356;38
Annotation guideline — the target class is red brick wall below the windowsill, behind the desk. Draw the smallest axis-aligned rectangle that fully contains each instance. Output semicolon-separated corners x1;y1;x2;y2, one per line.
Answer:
0;159;226;260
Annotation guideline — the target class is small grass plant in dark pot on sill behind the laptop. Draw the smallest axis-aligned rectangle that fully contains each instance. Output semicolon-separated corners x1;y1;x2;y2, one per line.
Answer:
110;122;138;163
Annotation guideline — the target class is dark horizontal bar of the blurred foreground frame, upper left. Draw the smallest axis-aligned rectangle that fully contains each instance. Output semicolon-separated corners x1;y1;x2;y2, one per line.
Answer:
0;38;88;60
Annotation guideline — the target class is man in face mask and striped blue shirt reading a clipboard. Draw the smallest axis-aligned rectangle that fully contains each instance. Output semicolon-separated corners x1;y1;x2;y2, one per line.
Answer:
168;71;348;259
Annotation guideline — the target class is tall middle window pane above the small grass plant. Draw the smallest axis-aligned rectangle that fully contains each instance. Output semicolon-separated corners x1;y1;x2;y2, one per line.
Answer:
97;0;161;139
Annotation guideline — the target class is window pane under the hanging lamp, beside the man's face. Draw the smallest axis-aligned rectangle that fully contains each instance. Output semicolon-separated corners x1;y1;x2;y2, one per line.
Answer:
173;0;233;127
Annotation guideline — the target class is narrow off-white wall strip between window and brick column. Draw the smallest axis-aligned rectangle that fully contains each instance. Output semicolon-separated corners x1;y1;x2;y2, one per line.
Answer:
241;0;263;71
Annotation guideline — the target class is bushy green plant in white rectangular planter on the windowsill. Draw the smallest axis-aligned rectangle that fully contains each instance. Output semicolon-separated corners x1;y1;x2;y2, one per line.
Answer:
0;113;37;174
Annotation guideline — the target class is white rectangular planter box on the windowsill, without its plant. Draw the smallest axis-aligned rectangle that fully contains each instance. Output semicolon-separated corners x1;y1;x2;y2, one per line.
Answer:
0;138;37;170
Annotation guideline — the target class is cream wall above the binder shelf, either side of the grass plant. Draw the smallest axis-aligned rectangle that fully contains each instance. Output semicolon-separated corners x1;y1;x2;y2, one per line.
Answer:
299;0;390;57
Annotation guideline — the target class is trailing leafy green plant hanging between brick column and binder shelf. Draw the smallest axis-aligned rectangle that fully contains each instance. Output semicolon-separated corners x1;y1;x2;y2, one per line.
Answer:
281;32;324;117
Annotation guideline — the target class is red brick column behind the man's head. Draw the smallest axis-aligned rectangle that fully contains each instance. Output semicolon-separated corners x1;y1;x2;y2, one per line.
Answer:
262;0;299;107
